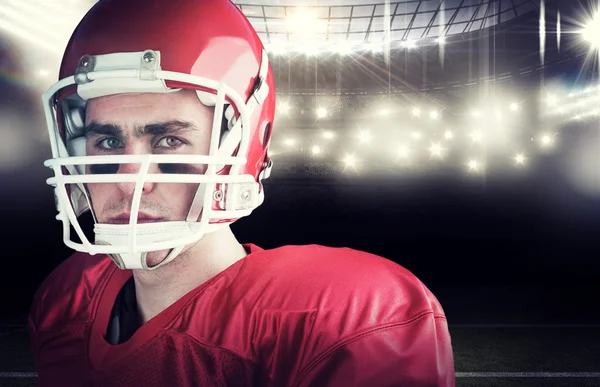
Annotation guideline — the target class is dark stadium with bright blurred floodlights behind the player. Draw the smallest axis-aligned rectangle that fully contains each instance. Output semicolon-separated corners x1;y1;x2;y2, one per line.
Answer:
0;0;600;386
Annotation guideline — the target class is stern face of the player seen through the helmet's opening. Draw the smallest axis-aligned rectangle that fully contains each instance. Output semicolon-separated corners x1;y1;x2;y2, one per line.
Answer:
85;90;214;224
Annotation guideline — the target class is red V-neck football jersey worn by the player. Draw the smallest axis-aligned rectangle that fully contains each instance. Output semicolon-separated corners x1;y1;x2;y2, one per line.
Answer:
29;244;455;387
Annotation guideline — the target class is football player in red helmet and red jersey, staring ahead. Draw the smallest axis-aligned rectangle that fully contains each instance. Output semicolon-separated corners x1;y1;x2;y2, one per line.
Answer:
29;0;455;387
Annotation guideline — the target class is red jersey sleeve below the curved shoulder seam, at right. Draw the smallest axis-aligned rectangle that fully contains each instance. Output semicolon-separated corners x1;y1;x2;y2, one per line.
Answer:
293;312;455;387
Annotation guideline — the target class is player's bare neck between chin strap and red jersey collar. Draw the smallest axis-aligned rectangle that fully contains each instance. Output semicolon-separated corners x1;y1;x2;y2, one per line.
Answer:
133;227;246;323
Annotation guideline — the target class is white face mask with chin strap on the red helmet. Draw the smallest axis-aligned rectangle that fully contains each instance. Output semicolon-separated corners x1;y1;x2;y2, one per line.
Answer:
43;50;272;270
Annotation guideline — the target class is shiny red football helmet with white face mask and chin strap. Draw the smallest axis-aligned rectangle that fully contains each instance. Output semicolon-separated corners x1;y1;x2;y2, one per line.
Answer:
43;0;275;269
